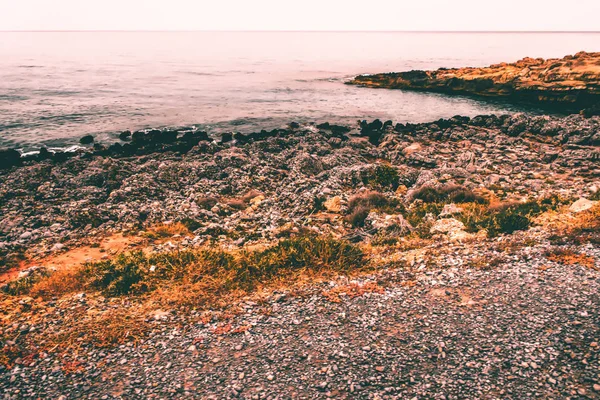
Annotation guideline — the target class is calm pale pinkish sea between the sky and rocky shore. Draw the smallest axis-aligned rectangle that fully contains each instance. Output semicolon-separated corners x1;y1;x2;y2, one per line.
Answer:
0;32;600;151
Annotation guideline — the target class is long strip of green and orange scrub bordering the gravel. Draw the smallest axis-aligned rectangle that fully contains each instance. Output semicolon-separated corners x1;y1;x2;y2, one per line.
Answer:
18;236;365;307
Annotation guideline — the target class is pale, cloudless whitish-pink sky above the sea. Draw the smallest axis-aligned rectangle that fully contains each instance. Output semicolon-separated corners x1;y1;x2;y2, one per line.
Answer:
0;0;600;31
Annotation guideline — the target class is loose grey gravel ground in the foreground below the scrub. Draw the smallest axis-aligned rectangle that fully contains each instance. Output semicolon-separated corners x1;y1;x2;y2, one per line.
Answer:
0;244;600;399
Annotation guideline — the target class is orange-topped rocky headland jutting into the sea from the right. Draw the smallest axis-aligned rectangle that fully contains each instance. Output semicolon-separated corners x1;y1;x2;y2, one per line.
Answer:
347;52;600;110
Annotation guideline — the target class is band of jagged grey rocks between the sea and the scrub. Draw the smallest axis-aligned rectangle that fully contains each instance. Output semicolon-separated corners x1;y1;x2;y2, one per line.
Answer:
0;114;600;264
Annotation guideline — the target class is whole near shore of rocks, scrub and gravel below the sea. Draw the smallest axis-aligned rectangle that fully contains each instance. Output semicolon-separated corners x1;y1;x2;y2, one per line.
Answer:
0;114;600;399
